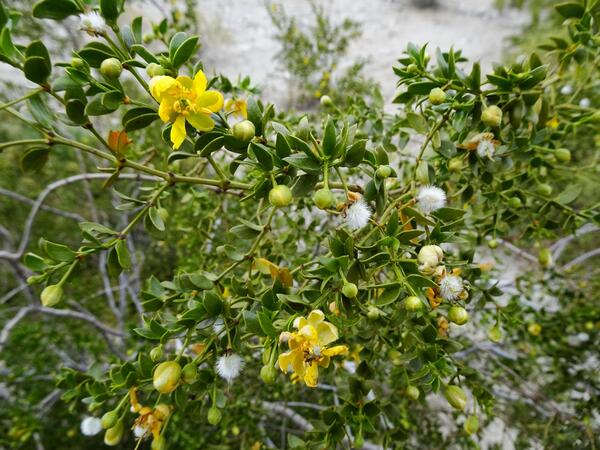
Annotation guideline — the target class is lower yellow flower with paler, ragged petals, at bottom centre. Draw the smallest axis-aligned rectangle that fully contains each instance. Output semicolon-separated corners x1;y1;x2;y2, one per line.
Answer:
278;309;348;387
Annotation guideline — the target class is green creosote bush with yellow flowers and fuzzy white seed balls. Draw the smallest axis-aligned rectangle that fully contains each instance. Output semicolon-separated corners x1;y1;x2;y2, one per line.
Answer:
0;0;600;450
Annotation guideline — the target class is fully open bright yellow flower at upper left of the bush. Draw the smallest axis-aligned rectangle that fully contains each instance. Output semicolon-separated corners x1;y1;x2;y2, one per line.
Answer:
150;70;223;149
